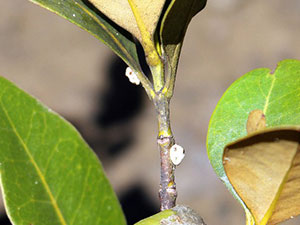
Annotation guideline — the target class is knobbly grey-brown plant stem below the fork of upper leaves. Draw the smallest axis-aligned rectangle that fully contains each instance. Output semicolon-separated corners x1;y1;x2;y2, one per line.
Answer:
154;94;177;211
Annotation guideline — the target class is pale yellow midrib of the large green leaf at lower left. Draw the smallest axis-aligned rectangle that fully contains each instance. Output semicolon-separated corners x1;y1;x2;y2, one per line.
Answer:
0;101;67;225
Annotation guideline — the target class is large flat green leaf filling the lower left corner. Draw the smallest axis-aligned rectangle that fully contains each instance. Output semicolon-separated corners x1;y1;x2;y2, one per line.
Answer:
0;77;126;225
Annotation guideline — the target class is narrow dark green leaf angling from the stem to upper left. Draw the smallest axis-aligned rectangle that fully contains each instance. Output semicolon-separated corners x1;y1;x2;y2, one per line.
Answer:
30;0;141;72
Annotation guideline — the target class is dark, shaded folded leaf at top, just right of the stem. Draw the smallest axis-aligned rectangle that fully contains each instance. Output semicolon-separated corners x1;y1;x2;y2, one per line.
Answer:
160;0;206;77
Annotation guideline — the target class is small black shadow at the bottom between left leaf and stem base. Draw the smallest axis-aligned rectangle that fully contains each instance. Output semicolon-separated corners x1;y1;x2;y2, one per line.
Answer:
119;184;159;225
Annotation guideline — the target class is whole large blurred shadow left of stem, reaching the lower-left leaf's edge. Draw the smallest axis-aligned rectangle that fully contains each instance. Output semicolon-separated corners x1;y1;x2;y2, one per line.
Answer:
67;53;147;168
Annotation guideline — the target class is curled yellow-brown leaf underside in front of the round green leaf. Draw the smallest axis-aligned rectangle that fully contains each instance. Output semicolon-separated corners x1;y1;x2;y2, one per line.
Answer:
223;127;300;225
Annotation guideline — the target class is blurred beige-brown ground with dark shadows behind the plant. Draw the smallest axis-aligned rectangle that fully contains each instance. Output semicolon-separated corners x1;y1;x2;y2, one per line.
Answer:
0;0;300;225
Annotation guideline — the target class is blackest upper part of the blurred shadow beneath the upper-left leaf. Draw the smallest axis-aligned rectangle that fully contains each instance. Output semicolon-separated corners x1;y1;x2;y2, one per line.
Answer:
96;57;144;128
